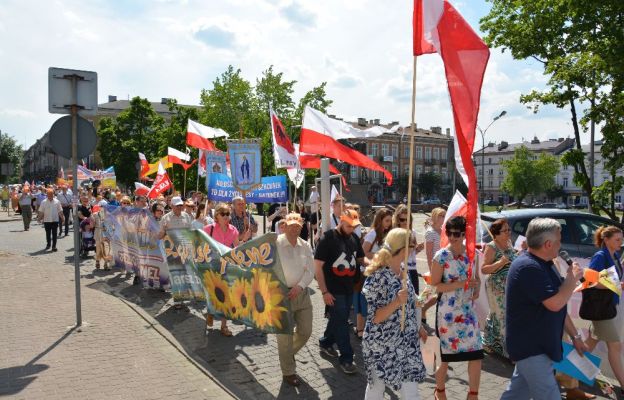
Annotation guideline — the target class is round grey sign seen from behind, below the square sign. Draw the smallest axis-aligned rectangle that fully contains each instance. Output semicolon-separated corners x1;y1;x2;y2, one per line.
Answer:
49;115;97;159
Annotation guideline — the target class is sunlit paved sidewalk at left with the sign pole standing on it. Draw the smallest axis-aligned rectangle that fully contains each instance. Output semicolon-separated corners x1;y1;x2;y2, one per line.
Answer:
0;221;232;400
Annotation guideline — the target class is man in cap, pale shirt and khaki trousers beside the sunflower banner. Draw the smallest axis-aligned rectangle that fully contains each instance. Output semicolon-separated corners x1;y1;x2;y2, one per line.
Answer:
276;213;314;386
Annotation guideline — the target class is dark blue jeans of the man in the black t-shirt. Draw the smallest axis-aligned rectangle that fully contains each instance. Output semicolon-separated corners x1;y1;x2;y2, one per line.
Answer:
319;294;353;364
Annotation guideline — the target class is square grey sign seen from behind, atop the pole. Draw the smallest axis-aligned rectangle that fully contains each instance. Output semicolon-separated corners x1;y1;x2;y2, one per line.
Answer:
48;67;97;115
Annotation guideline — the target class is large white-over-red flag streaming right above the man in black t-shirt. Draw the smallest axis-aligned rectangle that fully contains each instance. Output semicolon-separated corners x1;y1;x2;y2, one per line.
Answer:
299;106;396;186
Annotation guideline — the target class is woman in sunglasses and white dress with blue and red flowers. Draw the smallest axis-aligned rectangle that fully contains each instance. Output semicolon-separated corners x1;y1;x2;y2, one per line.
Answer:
431;217;483;400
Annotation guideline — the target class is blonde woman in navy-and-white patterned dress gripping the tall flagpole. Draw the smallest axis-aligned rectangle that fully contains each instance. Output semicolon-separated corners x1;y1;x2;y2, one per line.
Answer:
362;228;427;400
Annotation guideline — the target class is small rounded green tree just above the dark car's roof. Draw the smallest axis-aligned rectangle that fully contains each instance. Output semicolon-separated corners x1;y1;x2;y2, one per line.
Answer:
501;146;560;207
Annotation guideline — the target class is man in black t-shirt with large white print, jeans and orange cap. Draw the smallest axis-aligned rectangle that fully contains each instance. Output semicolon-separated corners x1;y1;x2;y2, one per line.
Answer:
314;210;365;374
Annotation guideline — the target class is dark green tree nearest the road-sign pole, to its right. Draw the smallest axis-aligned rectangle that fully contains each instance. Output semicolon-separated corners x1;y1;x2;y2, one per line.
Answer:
98;97;165;187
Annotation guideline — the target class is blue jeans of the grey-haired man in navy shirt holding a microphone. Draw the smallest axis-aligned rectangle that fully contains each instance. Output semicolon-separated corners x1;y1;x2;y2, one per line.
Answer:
501;354;561;400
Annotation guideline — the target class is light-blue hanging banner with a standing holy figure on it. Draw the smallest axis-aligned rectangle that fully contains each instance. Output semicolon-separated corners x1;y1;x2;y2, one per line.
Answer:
228;139;262;192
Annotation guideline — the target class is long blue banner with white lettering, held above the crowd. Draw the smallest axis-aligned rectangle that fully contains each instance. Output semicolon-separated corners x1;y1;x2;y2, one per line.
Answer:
208;174;288;203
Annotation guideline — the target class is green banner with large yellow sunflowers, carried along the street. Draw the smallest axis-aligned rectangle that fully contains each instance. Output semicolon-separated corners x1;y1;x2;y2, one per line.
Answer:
165;229;293;333
